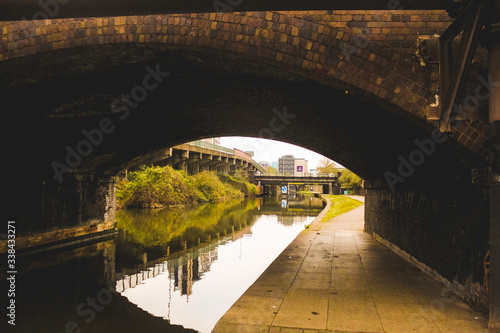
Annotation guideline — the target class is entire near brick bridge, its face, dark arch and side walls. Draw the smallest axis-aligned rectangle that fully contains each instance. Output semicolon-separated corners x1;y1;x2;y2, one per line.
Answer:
0;0;500;326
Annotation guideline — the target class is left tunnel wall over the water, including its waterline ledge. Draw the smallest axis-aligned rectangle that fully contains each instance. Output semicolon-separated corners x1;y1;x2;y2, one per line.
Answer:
0;175;117;253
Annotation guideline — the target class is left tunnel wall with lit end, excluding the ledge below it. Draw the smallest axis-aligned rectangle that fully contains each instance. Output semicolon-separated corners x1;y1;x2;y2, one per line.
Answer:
1;174;117;240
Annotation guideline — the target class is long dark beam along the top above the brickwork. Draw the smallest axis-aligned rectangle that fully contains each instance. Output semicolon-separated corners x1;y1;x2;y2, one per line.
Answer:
0;0;450;21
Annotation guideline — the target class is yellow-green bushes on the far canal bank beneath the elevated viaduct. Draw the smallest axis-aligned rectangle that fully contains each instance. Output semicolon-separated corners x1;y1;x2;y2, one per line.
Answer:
116;166;252;208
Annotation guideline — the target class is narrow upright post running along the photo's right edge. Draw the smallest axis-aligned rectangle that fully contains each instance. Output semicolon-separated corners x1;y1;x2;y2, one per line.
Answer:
486;0;500;331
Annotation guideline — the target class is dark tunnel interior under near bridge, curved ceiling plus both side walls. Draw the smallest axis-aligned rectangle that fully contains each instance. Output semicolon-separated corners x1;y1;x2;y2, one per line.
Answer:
0;13;488;324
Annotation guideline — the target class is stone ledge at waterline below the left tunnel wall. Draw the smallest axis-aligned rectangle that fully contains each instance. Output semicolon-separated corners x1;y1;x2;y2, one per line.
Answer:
0;222;116;254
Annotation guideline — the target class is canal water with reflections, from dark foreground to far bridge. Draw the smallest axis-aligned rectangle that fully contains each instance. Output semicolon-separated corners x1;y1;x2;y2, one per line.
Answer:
0;195;323;333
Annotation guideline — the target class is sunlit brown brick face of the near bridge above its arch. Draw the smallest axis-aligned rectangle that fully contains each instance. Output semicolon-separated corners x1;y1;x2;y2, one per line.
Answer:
0;11;487;158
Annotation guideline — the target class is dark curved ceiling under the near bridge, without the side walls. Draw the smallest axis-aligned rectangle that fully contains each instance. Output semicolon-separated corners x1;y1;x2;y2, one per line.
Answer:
0;44;482;184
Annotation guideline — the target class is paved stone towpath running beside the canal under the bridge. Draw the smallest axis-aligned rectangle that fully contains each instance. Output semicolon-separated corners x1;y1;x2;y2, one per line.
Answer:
213;198;488;333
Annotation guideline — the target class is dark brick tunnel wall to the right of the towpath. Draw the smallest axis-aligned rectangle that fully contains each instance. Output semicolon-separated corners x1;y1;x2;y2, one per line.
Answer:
365;185;489;306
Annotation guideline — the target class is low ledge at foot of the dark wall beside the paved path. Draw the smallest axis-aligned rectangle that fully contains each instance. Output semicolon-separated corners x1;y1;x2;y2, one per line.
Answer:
373;232;488;308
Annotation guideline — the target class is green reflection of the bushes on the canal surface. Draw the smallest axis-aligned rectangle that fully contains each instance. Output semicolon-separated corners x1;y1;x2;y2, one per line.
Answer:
117;200;256;248
